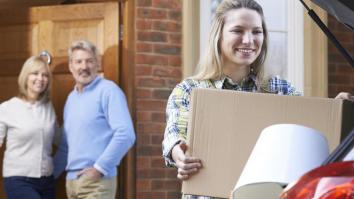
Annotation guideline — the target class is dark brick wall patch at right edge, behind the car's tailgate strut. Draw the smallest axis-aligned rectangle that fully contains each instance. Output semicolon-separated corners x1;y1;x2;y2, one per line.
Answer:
328;16;354;97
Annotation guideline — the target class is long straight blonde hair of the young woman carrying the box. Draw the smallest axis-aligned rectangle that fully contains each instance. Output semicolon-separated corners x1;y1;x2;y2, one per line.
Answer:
192;0;268;82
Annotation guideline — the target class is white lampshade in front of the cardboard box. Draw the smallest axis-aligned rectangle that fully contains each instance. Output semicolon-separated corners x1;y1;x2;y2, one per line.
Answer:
234;124;329;190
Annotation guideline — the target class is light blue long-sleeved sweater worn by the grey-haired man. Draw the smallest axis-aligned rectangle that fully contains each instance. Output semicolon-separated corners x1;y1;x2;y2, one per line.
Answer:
54;76;135;179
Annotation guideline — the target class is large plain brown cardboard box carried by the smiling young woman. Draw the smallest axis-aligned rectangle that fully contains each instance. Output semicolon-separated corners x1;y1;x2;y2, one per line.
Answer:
182;89;354;198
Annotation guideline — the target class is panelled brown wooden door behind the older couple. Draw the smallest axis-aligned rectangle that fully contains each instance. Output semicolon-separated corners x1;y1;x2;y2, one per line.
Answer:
0;2;119;199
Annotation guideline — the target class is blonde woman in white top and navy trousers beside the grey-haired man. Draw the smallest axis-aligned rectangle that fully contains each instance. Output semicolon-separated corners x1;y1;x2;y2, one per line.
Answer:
0;56;56;199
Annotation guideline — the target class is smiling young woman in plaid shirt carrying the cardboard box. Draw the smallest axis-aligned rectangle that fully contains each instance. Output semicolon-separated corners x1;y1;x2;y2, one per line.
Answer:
162;0;349;199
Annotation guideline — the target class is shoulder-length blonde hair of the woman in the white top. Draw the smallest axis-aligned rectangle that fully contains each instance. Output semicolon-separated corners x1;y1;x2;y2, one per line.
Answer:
18;56;52;102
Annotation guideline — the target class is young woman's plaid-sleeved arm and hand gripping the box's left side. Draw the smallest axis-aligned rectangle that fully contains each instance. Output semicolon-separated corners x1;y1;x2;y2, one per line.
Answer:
162;79;202;180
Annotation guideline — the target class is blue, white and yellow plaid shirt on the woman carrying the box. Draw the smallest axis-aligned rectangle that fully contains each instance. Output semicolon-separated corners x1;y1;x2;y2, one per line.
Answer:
162;75;300;199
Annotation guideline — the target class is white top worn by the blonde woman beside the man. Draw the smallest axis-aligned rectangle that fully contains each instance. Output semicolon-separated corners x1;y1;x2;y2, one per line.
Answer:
0;97;56;178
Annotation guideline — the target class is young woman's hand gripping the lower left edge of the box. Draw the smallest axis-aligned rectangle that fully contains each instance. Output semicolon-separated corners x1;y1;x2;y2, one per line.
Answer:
172;142;202;180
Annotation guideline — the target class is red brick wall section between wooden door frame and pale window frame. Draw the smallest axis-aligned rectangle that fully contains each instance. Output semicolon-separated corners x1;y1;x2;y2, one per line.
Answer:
135;0;182;199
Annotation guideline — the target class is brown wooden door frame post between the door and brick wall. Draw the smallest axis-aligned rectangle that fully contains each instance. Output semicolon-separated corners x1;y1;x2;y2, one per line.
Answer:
118;0;136;199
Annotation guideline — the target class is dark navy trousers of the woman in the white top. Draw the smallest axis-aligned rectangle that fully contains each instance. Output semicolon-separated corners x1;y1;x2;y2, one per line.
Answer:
4;176;55;199
